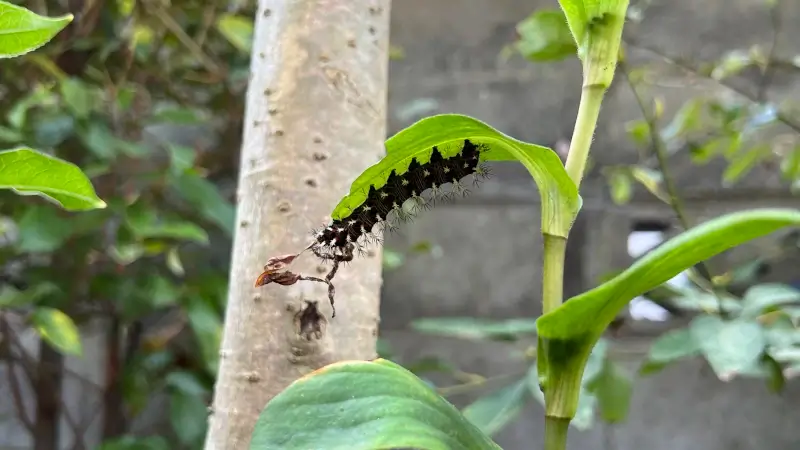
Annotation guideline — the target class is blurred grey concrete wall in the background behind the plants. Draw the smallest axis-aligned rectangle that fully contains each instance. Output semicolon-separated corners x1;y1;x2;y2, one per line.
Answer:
381;0;800;450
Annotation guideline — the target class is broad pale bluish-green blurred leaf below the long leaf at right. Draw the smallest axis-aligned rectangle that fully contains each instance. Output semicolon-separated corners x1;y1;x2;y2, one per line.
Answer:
690;316;767;381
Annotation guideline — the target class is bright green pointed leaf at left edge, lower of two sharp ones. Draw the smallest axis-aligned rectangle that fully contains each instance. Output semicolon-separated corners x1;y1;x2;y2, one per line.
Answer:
0;147;106;211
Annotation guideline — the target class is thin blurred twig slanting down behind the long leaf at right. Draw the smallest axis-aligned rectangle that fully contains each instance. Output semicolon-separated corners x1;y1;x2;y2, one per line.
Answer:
617;61;727;318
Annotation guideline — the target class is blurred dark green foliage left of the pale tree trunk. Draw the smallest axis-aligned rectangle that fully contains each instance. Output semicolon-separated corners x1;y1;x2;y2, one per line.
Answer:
0;0;255;450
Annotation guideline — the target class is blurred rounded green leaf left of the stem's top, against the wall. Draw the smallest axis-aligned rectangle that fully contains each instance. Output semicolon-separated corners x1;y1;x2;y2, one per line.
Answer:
516;10;577;61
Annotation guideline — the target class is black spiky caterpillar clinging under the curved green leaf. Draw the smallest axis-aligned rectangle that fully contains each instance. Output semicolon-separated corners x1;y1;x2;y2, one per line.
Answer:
310;139;490;262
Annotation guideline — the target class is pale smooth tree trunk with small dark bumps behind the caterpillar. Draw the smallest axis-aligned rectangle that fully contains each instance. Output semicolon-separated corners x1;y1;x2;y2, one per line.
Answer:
205;0;390;450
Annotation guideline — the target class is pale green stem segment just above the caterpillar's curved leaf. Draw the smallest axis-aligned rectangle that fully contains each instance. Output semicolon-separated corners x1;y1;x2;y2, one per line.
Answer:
566;84;606;187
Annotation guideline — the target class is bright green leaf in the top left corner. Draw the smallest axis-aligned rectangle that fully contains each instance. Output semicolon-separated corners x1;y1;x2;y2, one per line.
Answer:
0;1;72;58
